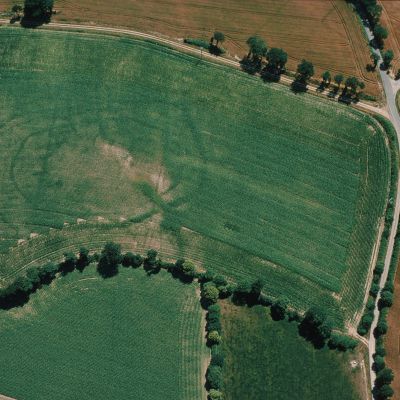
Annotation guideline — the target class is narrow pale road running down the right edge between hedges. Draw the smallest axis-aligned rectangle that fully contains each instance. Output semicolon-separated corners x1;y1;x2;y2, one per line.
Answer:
364;26;400;388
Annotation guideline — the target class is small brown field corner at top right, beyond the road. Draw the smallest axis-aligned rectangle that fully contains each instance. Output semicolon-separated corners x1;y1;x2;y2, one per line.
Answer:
380;0;400;72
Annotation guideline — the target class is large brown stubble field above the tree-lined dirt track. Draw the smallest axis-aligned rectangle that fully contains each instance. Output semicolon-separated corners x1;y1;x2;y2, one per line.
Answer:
0;0;381;98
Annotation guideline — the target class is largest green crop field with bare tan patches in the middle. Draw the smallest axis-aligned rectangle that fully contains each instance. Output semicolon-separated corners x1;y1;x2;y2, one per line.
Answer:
0;27;389;325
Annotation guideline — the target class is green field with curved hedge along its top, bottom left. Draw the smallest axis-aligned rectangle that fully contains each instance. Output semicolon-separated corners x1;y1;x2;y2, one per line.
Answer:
0;266;206;400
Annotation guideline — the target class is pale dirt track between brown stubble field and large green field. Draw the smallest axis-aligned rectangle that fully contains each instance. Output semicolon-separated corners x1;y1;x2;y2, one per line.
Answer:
0;19;390;118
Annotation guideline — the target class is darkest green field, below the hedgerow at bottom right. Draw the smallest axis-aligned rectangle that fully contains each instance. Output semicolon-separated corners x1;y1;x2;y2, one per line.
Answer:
222;302;369;400
